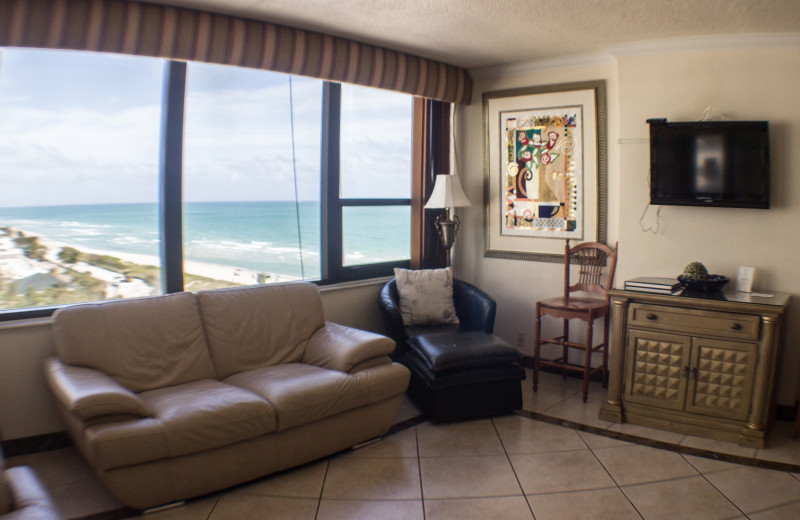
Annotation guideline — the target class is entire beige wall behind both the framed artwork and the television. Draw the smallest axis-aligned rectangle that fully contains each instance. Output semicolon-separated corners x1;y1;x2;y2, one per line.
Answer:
456;42;800;405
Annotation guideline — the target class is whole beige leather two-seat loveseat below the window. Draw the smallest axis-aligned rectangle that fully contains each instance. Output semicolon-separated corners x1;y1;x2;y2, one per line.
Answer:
45;283;409;509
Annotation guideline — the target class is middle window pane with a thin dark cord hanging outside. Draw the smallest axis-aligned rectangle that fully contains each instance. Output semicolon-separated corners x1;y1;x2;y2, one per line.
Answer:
183;63;323;290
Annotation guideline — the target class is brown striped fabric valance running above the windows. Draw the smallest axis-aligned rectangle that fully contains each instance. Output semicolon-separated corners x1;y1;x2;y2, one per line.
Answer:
0;0;472;104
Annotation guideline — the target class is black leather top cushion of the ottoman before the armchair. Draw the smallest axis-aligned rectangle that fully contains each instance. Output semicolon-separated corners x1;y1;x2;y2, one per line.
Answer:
408;331;522;373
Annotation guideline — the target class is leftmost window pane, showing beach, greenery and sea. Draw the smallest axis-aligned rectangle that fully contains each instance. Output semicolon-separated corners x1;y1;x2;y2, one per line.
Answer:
0;50;164;309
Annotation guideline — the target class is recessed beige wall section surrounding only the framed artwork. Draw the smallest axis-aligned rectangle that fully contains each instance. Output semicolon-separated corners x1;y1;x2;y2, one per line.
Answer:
453;57;619;364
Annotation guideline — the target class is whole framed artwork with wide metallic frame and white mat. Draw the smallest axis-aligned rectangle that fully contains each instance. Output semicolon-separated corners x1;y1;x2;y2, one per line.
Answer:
483;80;607;262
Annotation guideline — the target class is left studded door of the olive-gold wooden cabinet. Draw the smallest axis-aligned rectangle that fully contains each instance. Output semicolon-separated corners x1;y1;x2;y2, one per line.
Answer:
624;329;692;410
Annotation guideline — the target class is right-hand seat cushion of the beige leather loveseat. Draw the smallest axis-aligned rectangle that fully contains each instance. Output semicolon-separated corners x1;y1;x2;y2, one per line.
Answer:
224;363;369;431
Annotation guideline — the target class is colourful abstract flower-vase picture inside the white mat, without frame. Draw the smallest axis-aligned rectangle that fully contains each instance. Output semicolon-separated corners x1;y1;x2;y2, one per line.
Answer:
499;106;583;240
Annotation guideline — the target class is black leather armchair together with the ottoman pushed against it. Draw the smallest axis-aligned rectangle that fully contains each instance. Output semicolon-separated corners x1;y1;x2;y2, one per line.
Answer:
379;280;525;422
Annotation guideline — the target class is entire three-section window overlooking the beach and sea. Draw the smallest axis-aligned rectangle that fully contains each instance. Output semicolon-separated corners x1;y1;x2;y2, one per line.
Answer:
0;49;414;319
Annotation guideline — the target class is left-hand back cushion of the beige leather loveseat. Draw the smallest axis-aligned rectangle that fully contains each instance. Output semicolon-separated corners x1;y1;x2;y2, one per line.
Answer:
53;293;215;392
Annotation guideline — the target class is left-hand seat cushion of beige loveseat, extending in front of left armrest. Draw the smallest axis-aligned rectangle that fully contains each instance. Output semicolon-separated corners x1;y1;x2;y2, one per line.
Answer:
85;379;276;469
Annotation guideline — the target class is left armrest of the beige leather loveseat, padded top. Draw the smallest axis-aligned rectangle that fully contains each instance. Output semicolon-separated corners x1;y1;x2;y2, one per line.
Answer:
45;358;153;421
